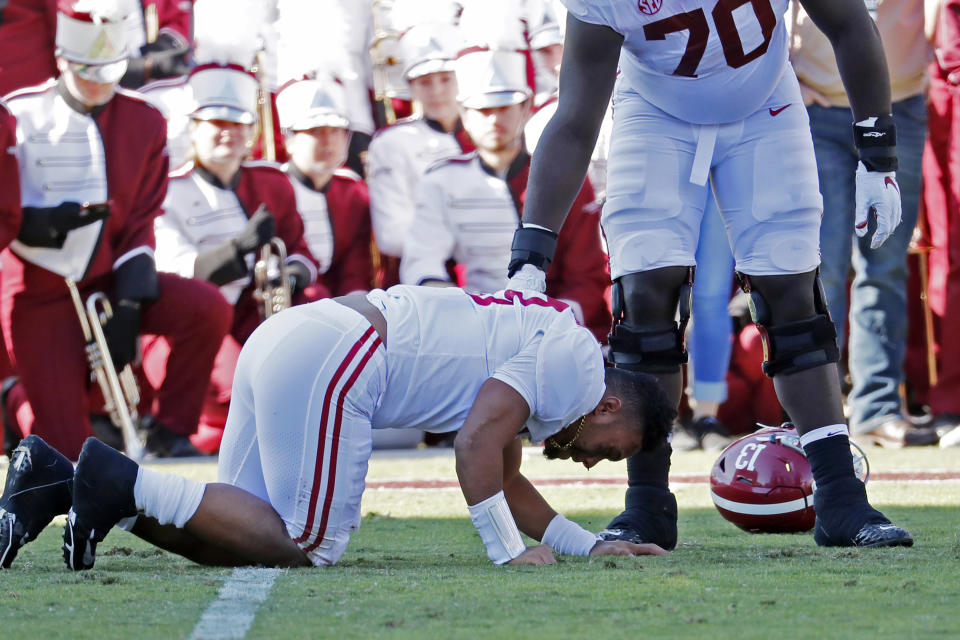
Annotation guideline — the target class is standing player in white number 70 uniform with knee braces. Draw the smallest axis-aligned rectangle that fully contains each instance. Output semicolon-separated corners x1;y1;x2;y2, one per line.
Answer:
509;0;913;548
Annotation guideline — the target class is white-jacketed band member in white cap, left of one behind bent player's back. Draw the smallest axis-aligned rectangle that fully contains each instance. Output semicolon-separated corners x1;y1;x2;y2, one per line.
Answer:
367;23;473;286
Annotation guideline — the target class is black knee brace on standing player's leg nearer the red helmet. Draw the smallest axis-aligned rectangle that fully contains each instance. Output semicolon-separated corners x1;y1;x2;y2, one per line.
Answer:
737;270;840;378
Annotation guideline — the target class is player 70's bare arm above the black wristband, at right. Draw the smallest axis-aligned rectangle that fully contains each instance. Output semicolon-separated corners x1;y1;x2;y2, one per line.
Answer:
800;0;892;122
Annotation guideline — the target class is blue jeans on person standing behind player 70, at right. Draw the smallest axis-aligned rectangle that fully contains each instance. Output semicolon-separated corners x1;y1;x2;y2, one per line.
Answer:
807;95;927;433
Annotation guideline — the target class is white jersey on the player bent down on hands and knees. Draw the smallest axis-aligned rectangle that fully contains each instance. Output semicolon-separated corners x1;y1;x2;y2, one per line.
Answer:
367;285;606;441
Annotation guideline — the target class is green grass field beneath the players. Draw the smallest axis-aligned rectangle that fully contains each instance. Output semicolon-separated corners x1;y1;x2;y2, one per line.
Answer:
0;448;960;640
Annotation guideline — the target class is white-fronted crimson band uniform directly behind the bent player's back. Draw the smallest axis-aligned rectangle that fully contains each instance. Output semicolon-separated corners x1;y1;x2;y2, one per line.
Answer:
400;152;611;340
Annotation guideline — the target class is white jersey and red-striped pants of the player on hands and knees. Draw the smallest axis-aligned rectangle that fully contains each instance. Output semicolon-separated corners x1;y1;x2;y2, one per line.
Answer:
218;286;605;565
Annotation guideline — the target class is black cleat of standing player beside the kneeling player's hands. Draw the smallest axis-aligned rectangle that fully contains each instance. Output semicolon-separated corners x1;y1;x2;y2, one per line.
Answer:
599;486;677;550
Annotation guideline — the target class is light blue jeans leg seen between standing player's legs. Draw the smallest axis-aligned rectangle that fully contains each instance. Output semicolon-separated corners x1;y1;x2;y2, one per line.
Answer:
690;190;734;402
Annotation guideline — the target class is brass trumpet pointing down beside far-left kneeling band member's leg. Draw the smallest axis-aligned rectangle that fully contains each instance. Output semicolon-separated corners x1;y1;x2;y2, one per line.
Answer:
66;278;143;462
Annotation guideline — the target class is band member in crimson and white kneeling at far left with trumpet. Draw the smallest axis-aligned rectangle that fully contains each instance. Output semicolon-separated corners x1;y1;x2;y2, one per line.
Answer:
0;0;230;458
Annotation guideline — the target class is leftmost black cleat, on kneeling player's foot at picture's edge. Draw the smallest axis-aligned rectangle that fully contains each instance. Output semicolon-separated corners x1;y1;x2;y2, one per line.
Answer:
0;435;73;569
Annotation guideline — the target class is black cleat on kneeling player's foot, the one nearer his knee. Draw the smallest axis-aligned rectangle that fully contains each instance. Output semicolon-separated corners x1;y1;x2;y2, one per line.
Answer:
63;438;139;571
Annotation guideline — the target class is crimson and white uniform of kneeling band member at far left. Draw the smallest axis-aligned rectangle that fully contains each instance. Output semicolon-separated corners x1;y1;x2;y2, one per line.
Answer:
0;80;229;458
